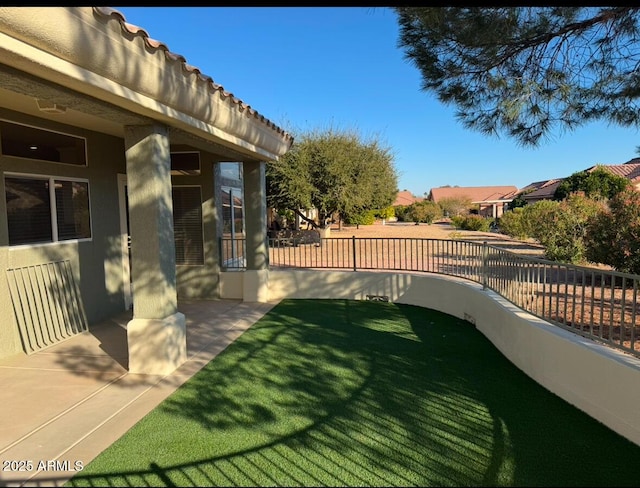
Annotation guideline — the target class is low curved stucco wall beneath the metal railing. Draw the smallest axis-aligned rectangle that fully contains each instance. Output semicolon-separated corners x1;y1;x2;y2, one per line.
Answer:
220;269;640;445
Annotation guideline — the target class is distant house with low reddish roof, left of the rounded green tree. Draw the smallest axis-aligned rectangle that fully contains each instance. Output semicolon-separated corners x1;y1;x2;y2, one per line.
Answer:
428;186;518;218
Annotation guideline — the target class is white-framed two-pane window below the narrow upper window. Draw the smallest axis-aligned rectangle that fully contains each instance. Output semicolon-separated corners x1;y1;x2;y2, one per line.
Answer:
4;176;91;246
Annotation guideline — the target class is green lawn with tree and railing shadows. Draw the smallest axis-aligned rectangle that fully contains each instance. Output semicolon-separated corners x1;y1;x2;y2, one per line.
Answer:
67;300;640;486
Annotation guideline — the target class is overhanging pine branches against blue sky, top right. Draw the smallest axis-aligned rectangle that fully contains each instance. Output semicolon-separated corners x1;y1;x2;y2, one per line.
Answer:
395;6;640;145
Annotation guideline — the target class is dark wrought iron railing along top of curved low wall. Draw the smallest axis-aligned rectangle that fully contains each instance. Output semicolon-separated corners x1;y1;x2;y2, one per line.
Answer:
220;237;640;357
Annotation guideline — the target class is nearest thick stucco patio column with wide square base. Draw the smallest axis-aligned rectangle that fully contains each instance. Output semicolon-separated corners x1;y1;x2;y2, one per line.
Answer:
125;125;187;375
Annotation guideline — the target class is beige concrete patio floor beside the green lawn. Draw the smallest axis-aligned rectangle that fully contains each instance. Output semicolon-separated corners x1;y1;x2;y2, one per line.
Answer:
0;300;275;486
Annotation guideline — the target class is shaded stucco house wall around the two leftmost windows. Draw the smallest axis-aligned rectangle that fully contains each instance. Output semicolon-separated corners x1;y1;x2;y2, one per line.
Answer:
0;108;125;358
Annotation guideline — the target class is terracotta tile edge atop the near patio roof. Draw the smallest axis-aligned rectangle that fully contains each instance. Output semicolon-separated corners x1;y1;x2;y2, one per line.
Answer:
93;7;293;143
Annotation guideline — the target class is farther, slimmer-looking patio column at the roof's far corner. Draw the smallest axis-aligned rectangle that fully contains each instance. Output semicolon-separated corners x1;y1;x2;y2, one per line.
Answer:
242;162;269;302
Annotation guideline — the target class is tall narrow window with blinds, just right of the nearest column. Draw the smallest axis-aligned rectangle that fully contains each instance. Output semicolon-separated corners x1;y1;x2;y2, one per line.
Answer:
172;186;204;265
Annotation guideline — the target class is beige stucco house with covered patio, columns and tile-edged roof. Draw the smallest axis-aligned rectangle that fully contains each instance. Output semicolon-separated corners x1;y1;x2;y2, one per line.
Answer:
0;7;293;374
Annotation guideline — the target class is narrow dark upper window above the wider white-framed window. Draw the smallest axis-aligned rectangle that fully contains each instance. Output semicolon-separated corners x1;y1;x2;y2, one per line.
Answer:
0;120;87;166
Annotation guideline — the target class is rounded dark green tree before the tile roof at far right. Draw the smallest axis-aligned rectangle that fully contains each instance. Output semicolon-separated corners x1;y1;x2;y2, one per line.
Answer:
553;166;631;200
